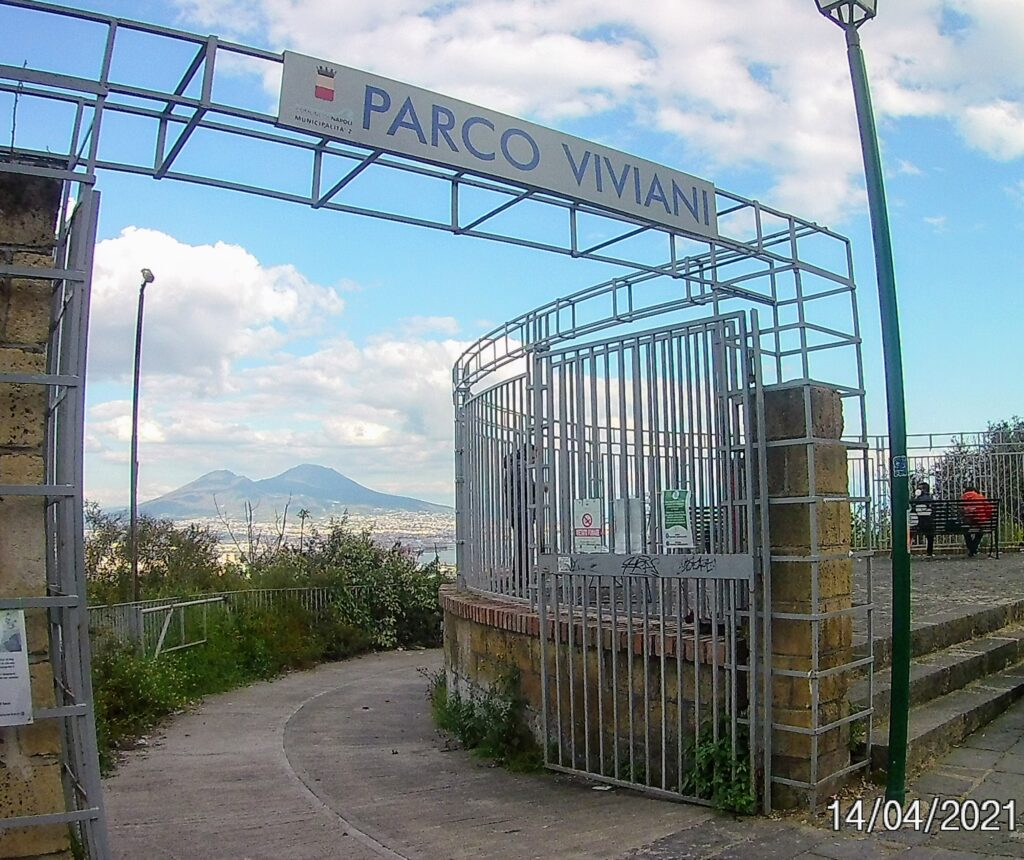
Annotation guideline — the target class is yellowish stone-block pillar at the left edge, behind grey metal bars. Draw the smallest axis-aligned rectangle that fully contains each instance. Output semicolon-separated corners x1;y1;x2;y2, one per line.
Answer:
0;165;72;858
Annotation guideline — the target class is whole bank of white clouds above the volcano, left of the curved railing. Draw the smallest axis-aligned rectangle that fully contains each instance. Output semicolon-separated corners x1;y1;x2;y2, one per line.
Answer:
87;228;467;504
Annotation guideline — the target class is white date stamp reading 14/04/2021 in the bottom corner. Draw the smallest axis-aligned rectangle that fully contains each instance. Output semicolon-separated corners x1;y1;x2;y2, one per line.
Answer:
825;798;1018;833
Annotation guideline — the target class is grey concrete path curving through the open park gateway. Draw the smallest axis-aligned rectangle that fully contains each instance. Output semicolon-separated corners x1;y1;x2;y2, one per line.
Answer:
105;651;1024;860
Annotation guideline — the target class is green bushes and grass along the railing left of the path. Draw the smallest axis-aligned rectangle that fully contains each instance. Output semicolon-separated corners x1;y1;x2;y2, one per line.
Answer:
86;506;452;770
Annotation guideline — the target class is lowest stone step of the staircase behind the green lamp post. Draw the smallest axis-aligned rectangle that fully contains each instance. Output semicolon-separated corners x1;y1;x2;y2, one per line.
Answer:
871;663;1024;771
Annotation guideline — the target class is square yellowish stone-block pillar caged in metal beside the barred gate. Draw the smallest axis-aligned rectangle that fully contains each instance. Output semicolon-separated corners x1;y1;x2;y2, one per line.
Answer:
765;382;853;809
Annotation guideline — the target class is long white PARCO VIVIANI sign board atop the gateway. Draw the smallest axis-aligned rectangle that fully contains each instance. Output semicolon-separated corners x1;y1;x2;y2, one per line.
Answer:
278;51;718;239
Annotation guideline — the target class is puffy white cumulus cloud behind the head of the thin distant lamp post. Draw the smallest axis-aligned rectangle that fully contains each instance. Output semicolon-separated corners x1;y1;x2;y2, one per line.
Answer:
89;227;344;390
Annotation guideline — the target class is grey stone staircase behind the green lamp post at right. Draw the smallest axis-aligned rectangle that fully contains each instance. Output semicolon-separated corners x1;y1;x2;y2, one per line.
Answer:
850;600;1024;770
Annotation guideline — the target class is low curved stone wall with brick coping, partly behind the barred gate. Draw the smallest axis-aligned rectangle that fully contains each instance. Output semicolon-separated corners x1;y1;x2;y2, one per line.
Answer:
441;588;746;790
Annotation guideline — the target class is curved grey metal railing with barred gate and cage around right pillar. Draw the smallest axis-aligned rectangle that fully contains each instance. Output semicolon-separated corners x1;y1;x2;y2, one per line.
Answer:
453;165;873;811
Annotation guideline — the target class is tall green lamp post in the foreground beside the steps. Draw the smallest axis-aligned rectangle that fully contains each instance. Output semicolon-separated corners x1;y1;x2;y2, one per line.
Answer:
815;0;910;803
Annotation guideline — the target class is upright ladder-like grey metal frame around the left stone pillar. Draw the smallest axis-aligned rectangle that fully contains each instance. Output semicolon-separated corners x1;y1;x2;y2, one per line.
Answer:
0;159;108;857
